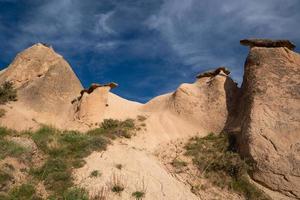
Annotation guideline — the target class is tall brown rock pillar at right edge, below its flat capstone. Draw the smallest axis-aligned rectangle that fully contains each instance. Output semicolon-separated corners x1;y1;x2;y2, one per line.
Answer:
239;47;300;199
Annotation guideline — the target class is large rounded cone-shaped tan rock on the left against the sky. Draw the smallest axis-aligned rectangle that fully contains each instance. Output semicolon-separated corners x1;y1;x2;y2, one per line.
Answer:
0;44;82;115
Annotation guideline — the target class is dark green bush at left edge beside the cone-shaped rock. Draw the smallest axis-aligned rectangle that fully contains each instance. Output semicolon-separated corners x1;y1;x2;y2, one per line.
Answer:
0;81;17;104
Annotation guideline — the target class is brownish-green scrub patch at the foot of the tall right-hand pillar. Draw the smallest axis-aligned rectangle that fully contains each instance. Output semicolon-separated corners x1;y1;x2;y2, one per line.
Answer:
185;133;270;200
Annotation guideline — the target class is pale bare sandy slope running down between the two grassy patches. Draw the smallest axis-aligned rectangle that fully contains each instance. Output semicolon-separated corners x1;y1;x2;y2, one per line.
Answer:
75;113;204;200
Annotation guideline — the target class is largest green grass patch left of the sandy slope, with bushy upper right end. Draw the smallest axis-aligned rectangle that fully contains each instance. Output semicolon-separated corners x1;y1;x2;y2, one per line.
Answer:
31;119;135;199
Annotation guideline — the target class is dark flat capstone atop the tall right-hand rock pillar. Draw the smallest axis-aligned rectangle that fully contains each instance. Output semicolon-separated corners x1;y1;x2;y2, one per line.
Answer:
240;39;296;50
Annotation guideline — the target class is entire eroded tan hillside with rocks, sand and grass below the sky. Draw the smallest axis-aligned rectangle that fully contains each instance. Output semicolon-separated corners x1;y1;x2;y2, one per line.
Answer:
0;40;300;200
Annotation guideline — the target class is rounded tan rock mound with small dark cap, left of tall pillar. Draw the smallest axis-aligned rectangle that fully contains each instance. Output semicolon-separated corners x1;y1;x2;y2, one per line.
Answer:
144;67;239;133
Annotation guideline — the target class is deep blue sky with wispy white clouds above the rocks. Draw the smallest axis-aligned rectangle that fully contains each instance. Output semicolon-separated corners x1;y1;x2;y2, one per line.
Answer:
0;0;300;102
